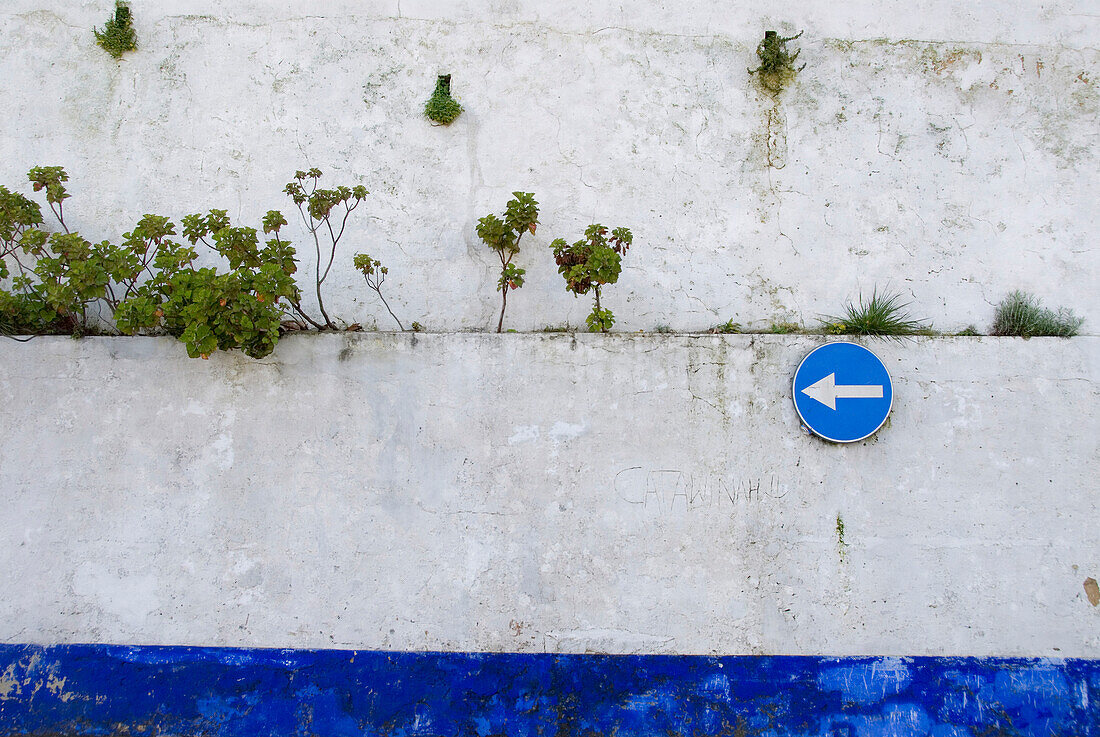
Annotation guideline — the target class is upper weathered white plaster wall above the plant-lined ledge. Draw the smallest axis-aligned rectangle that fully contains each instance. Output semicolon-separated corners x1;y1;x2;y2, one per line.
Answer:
0;0;1100;332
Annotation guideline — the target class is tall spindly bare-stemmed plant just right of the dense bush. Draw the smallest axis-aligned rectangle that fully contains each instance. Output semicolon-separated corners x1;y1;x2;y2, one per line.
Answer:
283;168;369;330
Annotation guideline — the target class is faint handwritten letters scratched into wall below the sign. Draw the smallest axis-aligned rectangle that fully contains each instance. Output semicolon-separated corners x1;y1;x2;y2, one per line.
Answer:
614;465;791;514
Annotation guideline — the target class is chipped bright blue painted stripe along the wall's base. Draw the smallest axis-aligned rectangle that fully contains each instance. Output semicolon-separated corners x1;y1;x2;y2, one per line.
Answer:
0;645;1100;737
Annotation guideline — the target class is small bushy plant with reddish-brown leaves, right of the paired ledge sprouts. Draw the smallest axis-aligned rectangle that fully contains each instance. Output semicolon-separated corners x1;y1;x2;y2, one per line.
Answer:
550;223;634;332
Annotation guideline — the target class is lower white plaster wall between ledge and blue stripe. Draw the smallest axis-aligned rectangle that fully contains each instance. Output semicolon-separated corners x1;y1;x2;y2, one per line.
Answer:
0;333;1100;658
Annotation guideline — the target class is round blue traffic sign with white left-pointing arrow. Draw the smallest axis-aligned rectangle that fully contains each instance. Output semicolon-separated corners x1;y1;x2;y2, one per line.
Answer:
792;343;893;442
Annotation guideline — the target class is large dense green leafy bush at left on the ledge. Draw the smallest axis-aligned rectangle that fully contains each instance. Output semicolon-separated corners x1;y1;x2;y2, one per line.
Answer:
0;166;300;358
